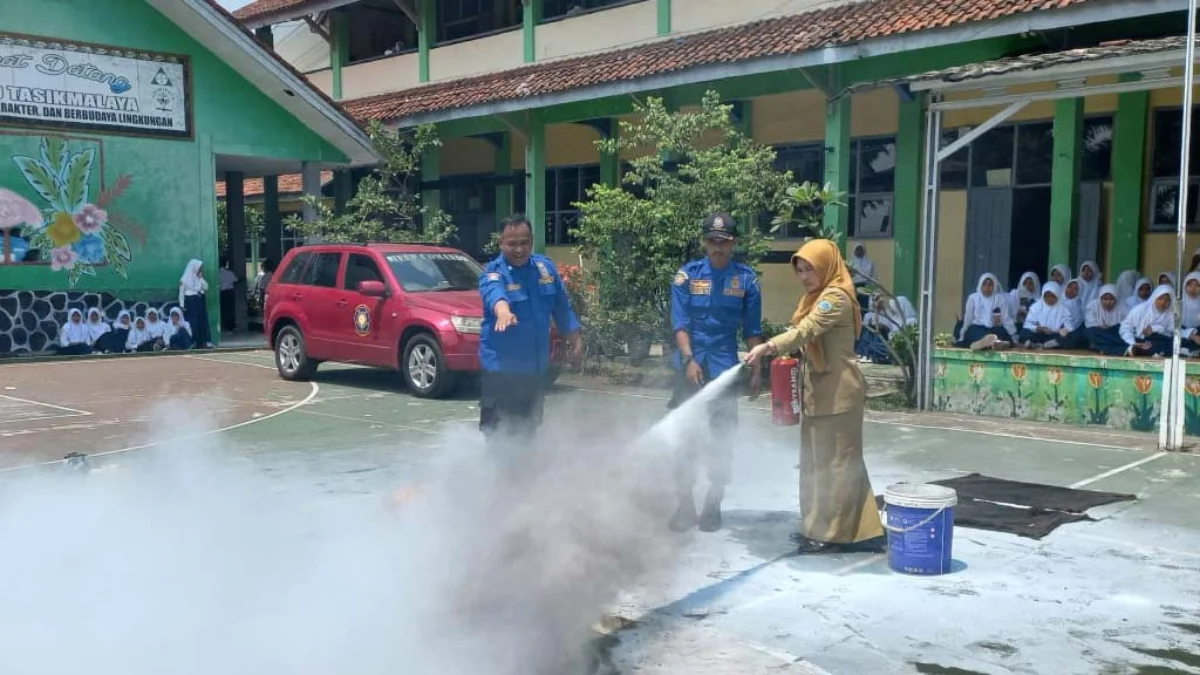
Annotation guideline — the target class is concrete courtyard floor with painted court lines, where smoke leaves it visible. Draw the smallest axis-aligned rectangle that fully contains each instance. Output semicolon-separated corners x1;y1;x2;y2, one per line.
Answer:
0;352;1200;675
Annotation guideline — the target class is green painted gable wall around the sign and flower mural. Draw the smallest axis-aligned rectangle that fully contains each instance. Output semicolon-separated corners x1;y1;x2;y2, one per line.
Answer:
0;0;346;338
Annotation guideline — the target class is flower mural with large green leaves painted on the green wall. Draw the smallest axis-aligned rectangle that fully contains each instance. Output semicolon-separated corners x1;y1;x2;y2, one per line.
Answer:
7;136;132;286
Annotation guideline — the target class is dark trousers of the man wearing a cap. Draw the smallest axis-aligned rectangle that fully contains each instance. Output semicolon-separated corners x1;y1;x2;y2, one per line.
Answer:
667;360;740;498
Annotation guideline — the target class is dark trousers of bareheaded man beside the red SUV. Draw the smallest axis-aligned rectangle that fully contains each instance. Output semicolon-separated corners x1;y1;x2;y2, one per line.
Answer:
479;370;546;441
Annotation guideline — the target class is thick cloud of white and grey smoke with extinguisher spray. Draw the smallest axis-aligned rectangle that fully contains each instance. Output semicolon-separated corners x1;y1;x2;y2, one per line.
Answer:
0;365;736;675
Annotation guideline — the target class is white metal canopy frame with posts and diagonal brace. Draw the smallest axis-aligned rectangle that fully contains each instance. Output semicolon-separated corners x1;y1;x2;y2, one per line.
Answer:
910;40;1196;448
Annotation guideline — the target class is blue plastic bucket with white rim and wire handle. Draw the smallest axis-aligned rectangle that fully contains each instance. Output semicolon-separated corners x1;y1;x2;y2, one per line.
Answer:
883;483;959;574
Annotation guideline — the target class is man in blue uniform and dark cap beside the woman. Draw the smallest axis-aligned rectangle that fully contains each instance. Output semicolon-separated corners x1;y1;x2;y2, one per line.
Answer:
668;214;762;532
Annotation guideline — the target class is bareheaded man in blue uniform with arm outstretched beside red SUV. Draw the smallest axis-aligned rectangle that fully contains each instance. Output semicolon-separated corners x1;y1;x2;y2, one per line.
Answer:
479;215;583;441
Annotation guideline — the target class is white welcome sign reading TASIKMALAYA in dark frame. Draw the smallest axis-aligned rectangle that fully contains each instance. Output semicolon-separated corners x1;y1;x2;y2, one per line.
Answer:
0;32;192;138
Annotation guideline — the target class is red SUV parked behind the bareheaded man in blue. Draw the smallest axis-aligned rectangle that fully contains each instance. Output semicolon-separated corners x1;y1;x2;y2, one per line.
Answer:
263;244;565;398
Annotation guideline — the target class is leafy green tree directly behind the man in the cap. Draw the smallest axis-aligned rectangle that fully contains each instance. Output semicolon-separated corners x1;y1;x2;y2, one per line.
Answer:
574;91;793;345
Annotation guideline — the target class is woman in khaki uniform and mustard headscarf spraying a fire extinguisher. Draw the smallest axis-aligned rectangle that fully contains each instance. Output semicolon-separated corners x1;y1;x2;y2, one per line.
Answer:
746;239;883;554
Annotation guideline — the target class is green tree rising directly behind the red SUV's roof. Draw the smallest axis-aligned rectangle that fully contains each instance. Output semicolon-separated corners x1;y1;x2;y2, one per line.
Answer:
287;121;455;244
